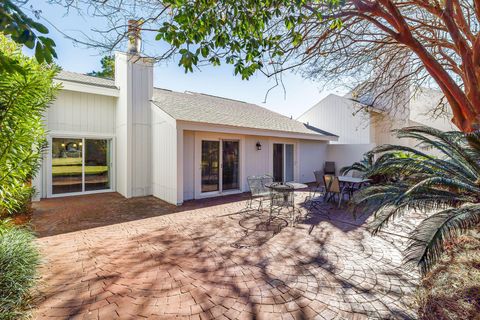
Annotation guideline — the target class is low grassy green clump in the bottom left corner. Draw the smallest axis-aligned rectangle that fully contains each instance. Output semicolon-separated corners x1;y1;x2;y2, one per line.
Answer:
0;221;40;320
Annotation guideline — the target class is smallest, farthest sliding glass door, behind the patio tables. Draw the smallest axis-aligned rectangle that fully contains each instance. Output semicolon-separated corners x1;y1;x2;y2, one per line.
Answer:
273;143;295;182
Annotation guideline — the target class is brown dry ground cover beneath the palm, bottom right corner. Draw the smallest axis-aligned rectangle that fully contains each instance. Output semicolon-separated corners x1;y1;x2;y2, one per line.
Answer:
416;232;480;320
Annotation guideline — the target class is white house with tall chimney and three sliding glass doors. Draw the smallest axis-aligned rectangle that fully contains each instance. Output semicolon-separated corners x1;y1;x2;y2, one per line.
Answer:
33;52;338;205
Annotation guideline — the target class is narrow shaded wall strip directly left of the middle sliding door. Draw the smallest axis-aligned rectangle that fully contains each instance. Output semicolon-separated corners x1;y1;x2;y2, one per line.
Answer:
183;131;195;200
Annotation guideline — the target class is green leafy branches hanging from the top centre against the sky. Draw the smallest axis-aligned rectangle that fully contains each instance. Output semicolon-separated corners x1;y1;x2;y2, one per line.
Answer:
156;0;343;79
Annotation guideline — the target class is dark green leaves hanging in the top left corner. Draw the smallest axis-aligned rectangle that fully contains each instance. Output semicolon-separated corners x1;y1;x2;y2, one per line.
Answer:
0;0;57;72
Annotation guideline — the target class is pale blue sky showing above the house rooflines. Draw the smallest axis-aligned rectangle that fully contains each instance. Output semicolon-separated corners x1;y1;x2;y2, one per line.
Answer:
26;0;344;118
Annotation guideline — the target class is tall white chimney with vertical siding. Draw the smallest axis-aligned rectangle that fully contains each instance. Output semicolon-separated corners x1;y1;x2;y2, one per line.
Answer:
115;53;153;198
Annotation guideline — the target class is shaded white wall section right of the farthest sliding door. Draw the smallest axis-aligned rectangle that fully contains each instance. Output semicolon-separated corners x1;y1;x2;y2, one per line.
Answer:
298;140;327;183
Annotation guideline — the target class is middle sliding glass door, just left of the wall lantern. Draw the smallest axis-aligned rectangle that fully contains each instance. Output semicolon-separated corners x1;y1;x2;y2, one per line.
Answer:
201;140;240;193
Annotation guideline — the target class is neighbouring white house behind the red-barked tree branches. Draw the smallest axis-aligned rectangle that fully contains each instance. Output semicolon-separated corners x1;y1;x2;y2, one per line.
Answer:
297;88;458;169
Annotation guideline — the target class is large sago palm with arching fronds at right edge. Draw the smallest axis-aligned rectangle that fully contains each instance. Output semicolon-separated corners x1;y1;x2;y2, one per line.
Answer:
354;127;480;274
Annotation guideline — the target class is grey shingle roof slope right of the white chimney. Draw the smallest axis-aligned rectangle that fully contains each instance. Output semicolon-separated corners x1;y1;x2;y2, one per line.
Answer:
152;88;335;137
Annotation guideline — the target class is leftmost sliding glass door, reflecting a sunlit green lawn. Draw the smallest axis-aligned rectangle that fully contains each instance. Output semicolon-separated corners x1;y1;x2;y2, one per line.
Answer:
51;138;111;195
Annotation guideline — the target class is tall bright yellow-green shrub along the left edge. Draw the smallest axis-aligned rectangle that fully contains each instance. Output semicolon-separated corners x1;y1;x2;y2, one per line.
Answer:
0;34;58;216
